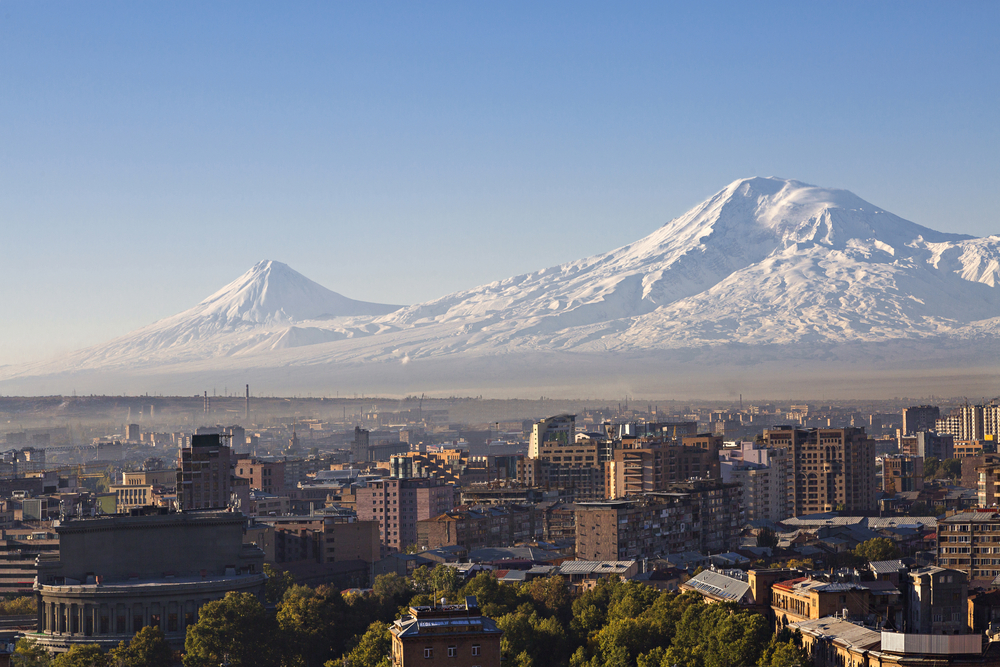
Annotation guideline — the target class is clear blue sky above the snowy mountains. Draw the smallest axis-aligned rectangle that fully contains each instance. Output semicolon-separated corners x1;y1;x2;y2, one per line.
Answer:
0;0;1000;364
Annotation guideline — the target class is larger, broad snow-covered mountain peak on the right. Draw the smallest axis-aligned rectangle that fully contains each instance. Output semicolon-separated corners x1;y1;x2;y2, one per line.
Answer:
382;178;1000;347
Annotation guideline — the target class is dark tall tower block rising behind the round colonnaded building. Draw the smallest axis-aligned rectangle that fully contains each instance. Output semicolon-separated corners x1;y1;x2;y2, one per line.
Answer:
177;433;230;510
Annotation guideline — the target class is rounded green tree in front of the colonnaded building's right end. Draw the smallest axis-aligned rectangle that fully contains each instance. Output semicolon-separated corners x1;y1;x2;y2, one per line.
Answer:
184;592;279;667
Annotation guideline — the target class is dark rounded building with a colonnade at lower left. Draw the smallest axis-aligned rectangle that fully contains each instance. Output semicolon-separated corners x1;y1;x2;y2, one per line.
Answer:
28;510;267;651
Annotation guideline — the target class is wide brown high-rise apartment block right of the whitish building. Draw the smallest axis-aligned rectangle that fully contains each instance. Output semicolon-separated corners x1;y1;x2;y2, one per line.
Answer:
764;426;876;516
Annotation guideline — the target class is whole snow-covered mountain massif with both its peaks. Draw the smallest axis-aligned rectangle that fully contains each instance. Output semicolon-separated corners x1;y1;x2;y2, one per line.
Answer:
0;178;1000;393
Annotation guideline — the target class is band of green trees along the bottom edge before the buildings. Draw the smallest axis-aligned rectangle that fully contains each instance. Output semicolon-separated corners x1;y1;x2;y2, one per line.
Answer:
15;565;809;667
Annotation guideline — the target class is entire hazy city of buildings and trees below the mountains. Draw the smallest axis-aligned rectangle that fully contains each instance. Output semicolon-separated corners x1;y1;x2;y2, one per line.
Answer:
0;394;1000;667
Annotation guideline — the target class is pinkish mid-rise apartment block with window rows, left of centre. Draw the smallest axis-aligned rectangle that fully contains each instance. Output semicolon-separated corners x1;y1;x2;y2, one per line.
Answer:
356;477;455;556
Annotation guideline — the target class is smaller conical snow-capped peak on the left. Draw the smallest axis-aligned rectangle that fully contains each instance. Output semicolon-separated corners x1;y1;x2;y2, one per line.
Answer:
186;260;399;324
